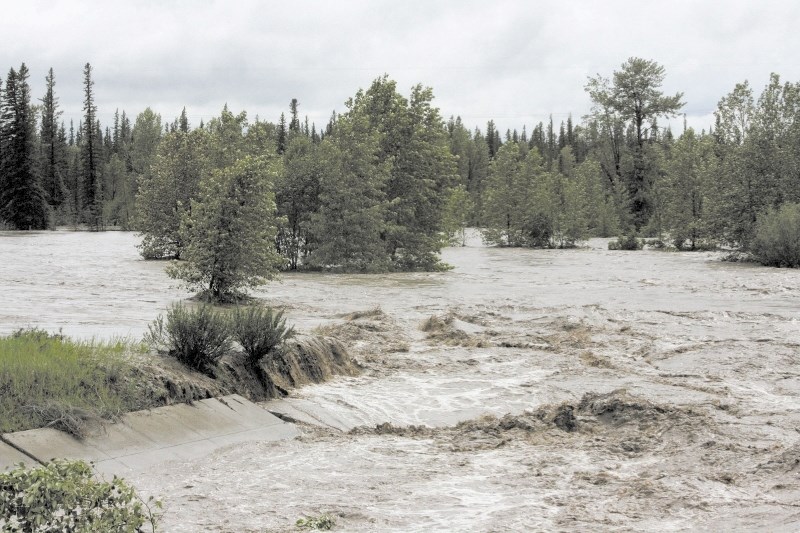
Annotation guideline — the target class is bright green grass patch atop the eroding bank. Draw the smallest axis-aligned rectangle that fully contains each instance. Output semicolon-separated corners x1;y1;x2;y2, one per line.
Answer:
0;329;142;436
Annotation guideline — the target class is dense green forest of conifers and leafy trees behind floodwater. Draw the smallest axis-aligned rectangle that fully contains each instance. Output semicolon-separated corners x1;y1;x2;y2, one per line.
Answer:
0;58;800;276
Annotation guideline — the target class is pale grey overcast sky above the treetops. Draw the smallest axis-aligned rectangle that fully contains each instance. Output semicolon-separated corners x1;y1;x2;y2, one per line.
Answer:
0;0;800;137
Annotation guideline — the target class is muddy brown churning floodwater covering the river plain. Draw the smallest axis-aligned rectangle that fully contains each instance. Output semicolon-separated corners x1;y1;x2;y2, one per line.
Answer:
0;232;800;532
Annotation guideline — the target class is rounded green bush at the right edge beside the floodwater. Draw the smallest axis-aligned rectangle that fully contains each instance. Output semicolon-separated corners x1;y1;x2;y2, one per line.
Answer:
751;203;800;268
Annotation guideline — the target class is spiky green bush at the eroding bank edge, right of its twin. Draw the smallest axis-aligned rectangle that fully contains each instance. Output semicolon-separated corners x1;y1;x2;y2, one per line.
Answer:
230;305;294;365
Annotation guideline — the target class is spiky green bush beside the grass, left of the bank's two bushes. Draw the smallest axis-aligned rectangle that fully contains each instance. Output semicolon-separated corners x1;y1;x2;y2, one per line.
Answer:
145;303;231;373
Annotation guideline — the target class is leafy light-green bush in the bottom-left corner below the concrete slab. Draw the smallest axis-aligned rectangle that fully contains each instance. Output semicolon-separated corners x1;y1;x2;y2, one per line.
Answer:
0;459;161;532
